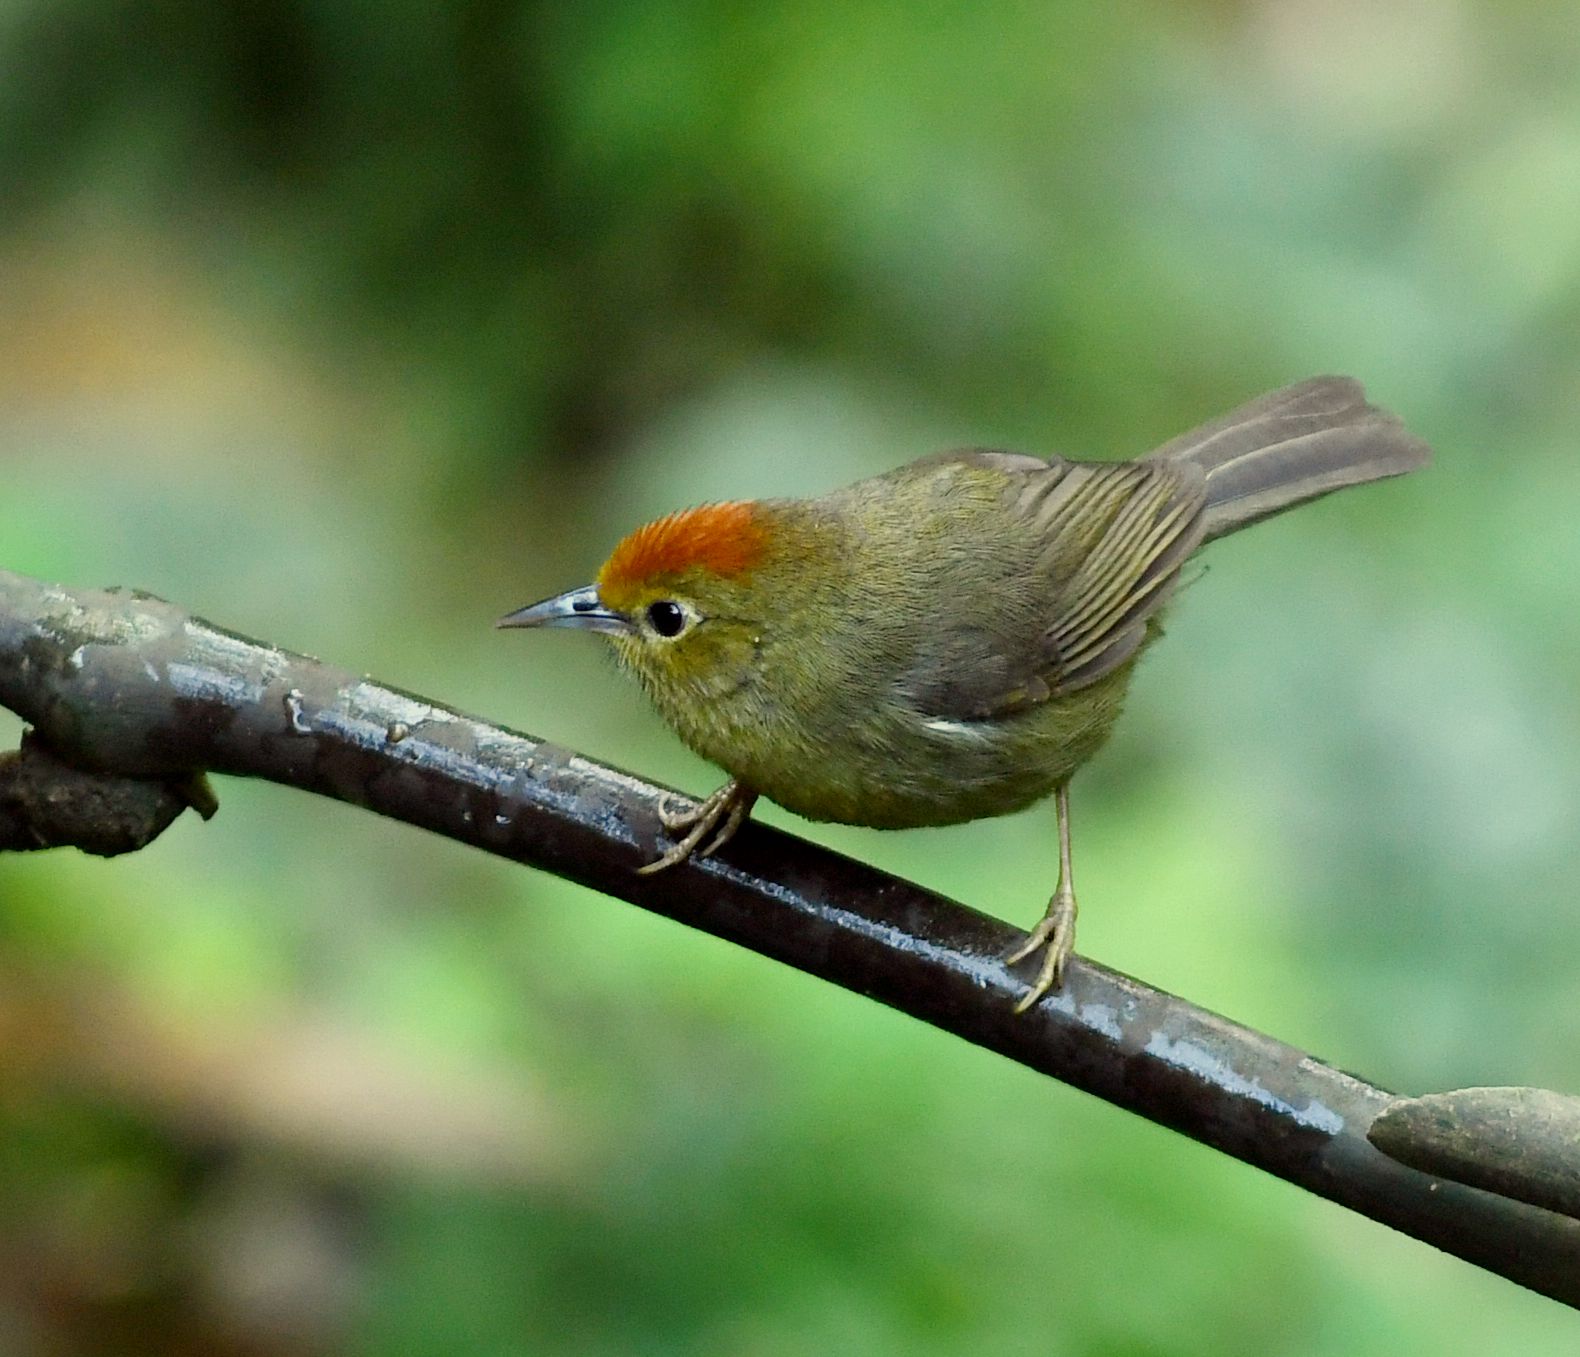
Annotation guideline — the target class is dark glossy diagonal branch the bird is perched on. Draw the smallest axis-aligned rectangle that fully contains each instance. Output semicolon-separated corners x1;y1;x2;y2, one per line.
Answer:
0;572;1580;1306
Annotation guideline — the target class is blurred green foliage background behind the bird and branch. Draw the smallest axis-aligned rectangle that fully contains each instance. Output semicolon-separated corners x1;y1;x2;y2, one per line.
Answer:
0;0;1580;1357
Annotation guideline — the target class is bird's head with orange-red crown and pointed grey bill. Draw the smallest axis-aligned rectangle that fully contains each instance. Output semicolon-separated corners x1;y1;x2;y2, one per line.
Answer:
498;501;773;716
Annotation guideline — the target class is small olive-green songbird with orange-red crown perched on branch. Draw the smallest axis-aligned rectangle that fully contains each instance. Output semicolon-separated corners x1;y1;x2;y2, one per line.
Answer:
499;378;1430;1011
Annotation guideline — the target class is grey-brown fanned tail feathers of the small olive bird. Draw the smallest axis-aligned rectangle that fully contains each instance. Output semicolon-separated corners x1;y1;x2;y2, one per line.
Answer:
1149;378;1431;540
